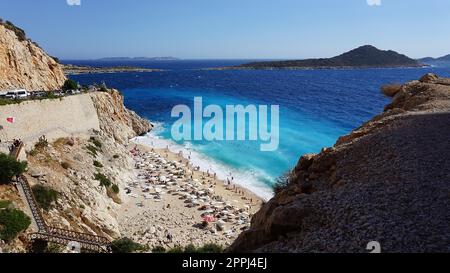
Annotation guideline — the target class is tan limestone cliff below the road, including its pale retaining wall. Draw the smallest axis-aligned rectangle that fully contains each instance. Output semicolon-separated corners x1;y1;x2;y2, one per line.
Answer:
0;90;151;245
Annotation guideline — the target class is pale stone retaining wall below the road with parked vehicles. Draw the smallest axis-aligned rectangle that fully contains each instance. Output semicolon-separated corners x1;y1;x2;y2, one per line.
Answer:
0;94;100;148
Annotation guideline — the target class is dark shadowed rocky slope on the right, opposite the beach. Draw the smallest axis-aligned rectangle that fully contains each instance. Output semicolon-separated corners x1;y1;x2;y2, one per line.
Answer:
229;74;450;252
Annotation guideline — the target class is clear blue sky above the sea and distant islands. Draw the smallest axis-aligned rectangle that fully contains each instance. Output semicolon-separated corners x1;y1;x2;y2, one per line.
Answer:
0;0;450;59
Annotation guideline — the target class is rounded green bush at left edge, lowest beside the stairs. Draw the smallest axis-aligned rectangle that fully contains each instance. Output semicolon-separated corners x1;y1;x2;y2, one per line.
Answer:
0;209;31;242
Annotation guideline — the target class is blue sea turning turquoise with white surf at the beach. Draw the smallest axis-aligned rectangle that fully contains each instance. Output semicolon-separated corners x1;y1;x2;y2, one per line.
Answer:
65;60;450;198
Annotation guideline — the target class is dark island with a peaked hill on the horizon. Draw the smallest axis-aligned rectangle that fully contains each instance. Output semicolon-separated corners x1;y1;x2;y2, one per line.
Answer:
227;45;427;69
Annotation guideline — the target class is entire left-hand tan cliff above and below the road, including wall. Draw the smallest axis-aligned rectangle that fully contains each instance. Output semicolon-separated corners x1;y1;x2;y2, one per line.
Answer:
0;21;151;249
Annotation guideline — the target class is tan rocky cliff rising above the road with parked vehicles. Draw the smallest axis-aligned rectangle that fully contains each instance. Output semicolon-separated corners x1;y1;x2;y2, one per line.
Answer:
0;23;66;91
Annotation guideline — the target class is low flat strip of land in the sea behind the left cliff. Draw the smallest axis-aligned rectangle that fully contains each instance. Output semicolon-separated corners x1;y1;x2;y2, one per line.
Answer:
62;64;162;75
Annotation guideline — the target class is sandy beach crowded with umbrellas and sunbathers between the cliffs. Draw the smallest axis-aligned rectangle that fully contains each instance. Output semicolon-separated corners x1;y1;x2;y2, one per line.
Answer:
119;141;263;249
